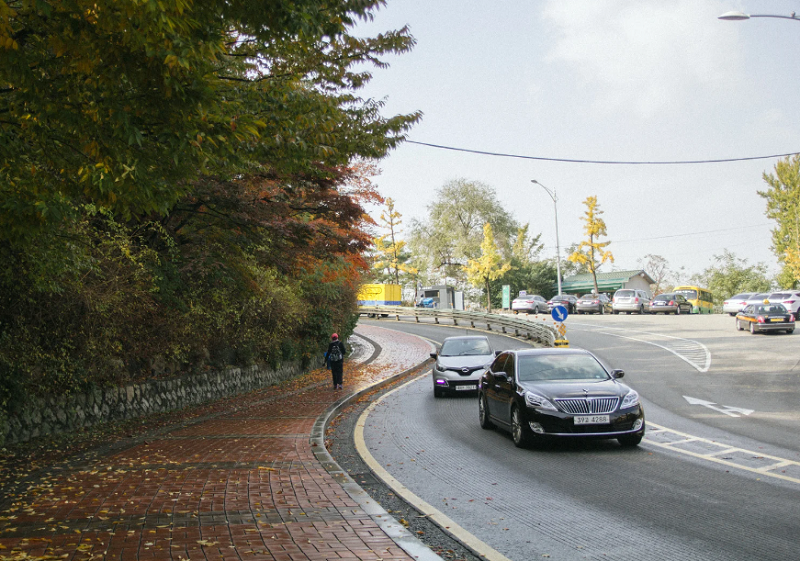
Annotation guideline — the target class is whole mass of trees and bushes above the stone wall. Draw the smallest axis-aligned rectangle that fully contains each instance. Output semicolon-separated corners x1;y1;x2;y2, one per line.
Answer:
0;0;419;434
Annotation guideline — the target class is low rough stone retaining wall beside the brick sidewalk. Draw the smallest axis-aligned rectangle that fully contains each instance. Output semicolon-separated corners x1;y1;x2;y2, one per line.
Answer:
0;364;301;445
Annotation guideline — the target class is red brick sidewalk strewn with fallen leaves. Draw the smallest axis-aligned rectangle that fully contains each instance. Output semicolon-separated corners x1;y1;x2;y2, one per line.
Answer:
0;325;430;561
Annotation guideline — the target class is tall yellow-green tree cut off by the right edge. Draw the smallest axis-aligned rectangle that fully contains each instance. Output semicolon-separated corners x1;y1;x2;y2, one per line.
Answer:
758;155;800;288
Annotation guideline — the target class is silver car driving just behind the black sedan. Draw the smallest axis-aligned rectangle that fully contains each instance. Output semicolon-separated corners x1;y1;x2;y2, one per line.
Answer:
431;335;495;397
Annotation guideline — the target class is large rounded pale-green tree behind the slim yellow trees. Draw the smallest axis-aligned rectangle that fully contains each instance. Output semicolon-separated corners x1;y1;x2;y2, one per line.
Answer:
409;179;519;282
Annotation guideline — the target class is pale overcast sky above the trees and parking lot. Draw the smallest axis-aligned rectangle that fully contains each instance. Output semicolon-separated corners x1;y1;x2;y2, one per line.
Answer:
358;0;800;280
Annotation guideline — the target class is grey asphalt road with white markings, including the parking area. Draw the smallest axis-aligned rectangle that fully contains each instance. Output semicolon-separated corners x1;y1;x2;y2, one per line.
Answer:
342;316;800;561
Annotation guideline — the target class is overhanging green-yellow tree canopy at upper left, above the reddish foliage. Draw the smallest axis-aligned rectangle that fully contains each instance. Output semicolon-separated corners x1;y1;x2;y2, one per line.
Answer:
0;0;419;241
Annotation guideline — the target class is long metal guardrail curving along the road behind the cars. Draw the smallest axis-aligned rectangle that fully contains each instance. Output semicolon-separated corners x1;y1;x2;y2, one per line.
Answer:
358;306;560;347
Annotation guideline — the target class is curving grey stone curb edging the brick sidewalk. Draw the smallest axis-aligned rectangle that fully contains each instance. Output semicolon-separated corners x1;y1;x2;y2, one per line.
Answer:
309;335;442;561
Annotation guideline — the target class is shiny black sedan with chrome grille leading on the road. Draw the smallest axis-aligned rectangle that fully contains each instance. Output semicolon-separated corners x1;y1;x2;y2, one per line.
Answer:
478;349;645;447
